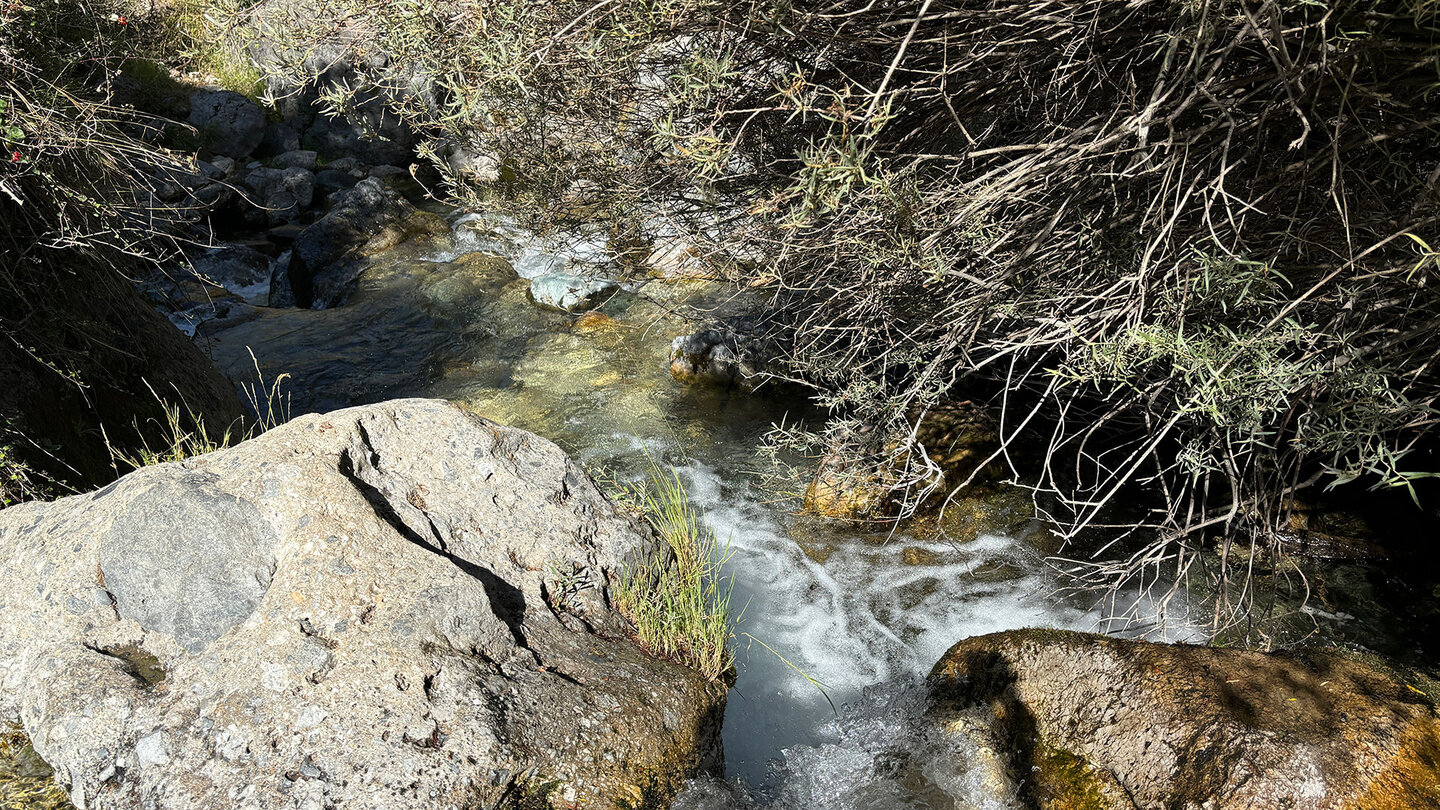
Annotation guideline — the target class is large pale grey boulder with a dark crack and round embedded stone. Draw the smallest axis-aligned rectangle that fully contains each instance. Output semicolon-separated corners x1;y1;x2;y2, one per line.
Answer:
0;399;724;810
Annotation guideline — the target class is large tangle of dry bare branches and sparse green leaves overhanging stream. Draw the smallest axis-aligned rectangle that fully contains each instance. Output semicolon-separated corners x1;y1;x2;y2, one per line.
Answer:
236;0;1440;621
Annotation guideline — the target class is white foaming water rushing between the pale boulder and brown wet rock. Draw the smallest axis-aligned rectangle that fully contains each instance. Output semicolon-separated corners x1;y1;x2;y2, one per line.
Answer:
662;463;1099;810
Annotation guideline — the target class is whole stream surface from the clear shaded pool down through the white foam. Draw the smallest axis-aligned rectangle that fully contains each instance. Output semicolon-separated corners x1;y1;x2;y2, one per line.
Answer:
207;211;1192;810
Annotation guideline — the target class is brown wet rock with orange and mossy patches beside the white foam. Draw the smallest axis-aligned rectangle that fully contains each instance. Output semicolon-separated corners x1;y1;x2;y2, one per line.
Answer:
930;630;1440;810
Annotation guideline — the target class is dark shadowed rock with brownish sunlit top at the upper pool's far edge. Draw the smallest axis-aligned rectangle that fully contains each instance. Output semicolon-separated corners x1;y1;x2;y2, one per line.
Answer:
289;179;449;308
